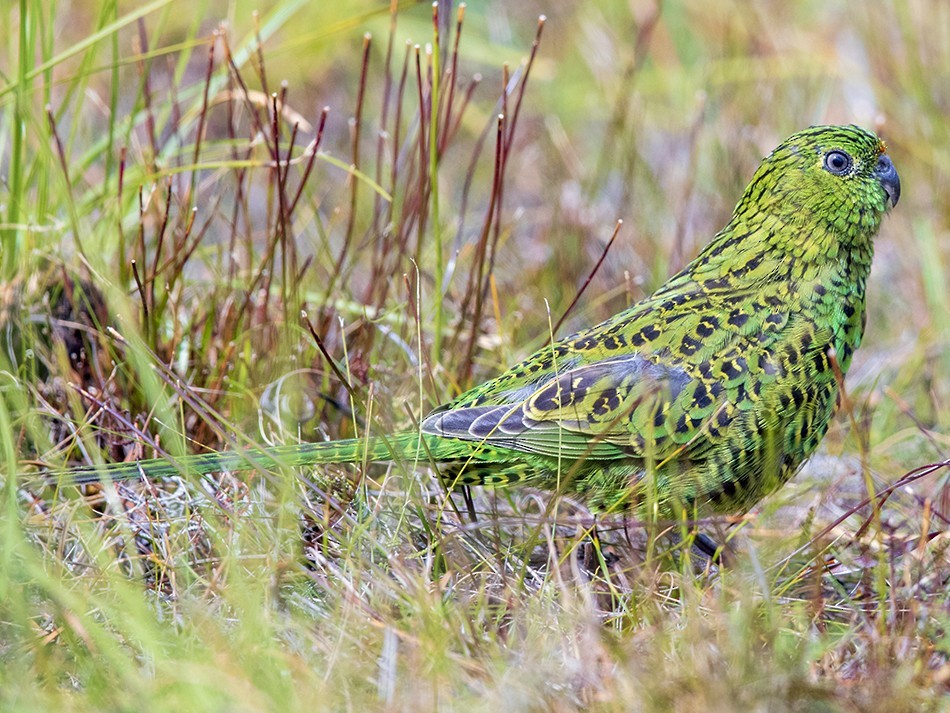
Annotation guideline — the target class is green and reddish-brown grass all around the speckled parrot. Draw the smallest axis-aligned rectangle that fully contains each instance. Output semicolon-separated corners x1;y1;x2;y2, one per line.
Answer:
0;0;950;711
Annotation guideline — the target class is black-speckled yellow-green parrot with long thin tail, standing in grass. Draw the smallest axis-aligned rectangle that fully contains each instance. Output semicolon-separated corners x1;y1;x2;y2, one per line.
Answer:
46;126;900;514
